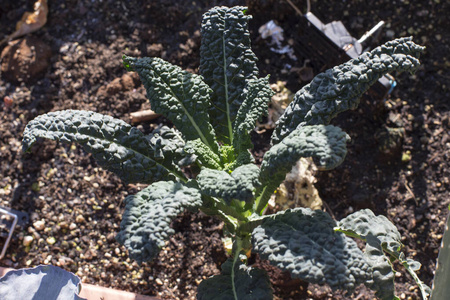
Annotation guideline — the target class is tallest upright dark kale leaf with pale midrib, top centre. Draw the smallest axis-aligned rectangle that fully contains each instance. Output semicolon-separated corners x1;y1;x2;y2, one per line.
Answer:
200;6;258;145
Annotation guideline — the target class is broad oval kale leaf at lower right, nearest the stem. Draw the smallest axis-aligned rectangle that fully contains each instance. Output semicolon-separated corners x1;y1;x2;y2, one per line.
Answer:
252;208;372;291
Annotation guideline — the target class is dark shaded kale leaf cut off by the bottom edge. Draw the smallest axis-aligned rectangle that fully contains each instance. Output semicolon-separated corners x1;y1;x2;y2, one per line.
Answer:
197;259;273;300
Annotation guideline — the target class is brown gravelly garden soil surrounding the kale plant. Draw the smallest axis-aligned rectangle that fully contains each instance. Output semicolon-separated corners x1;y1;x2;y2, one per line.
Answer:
0;0;450;299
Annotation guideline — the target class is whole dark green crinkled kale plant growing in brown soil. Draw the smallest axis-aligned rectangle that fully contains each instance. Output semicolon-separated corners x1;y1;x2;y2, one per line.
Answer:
23;7;428;299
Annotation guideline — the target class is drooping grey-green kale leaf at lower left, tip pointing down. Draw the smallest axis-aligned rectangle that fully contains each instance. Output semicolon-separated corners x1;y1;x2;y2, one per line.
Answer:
116;181;202;262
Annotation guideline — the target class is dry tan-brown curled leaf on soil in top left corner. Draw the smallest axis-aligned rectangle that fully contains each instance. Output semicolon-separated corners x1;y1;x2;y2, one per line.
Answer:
0;0;48;45
